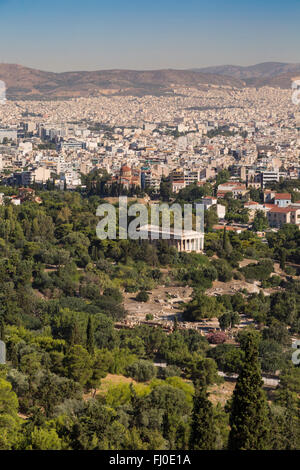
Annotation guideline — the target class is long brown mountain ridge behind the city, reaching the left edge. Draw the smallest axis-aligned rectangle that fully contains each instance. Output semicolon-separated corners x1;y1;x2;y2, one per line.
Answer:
0;64;244;100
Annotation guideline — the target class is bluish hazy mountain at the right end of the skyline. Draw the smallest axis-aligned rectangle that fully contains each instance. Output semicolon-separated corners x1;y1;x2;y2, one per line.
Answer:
191;62;300;88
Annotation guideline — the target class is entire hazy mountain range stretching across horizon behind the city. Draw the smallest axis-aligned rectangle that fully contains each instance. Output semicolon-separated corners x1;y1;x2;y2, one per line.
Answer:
0;62;300;100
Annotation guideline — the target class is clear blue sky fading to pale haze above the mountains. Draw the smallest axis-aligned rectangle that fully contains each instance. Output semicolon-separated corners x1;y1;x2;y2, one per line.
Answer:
0;0;300;71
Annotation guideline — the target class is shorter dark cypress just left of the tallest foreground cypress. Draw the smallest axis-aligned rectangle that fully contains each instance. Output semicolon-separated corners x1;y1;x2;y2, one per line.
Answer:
189;384;216;450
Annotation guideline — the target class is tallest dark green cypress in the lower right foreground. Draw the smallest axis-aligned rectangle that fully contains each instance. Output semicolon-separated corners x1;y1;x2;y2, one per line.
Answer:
228;332;269;450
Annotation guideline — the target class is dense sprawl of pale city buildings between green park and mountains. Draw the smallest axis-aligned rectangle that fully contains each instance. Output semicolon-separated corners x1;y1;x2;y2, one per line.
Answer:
0;86;299;193
